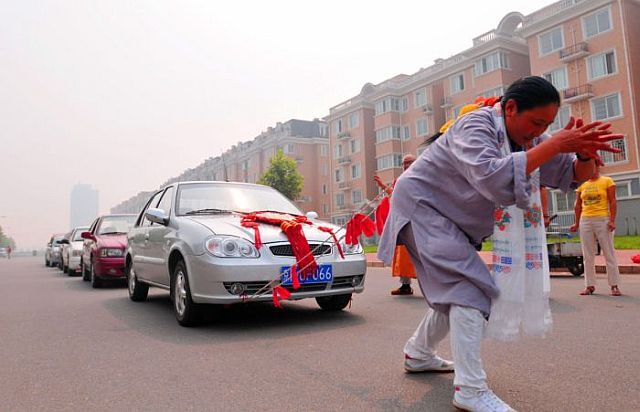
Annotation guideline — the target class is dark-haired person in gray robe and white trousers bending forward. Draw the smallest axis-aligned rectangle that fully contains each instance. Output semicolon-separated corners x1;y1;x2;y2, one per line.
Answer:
378;76;621;411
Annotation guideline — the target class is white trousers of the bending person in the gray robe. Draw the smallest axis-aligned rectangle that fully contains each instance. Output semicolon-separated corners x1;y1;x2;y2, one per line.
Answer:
404;305;487;394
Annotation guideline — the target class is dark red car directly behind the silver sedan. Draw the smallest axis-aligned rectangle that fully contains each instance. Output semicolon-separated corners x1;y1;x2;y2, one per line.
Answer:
80;215;136;288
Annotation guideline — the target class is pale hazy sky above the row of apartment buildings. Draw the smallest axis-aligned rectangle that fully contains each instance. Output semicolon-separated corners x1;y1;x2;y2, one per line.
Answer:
0;0;551;248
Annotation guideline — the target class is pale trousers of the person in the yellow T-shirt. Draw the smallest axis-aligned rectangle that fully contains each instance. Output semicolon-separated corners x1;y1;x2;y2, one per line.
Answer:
580;216;620;286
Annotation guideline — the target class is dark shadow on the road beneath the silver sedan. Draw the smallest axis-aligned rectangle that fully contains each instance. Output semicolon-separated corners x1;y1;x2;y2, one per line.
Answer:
103;290;366;345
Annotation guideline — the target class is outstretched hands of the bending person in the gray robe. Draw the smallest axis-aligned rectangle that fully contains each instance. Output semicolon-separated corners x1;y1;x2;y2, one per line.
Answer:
549;116;624;159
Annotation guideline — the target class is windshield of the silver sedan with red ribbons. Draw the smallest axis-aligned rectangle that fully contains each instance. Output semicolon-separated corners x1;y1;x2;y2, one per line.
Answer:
176;183;302;215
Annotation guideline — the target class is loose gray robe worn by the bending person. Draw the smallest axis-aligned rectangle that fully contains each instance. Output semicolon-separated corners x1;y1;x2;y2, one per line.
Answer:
378;107;575;314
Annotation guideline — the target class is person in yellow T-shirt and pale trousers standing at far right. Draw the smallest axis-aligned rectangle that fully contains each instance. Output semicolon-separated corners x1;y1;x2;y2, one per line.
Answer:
570;169;621;296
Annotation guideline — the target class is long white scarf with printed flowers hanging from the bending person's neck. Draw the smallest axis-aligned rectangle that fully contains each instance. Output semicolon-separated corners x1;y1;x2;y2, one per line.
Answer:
485;108;553;340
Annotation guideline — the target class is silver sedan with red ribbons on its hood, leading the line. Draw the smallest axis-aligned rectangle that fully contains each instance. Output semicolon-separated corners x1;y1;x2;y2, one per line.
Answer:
126;182;366;326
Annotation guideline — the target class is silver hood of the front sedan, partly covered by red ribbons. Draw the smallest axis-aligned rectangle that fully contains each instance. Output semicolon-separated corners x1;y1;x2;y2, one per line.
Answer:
185;215;344;243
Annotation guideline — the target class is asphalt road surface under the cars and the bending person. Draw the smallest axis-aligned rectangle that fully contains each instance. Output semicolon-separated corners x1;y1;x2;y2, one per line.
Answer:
0;258;640;411
